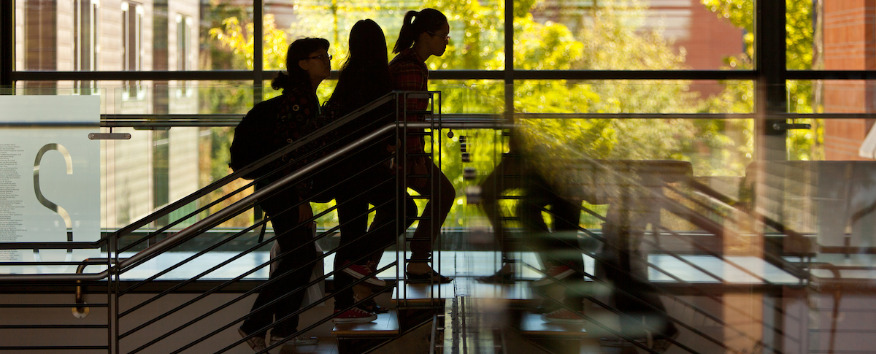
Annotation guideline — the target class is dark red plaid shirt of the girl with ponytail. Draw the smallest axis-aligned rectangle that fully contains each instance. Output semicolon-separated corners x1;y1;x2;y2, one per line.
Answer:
389;48;429;153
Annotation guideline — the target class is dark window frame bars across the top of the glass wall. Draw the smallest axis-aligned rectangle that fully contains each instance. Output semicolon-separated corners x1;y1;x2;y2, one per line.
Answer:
0;0;876;148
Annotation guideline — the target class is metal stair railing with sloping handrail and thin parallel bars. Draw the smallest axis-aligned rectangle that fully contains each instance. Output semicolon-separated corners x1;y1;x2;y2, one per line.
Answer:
0;95;840;352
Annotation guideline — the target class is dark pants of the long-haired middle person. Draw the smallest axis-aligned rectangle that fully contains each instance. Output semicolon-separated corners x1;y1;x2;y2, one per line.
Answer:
334;166;417;309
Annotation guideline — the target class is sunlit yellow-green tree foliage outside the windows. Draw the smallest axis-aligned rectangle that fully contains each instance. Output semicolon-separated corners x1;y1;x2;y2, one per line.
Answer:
202;0;784;225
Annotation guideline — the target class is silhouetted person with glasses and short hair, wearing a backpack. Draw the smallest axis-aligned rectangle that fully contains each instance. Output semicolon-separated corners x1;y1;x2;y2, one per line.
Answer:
239;38;331;351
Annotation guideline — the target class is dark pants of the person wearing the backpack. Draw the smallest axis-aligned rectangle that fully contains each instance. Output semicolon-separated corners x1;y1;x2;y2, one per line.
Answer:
240;186;317;336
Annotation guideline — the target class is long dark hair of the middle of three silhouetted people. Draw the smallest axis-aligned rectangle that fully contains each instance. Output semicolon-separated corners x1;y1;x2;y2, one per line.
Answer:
326;19;392;114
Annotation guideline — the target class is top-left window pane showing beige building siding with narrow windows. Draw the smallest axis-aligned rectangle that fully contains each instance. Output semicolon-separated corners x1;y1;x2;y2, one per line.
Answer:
15;0;252;71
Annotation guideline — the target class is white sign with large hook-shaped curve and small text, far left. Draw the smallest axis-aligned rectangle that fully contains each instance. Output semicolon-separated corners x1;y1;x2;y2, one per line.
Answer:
0;96;101;273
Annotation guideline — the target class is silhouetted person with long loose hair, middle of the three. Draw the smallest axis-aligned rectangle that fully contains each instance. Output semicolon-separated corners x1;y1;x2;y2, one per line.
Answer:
324;19;417;323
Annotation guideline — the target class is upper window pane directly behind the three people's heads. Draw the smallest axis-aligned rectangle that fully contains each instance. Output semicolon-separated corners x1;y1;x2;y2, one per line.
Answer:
264;0;505;70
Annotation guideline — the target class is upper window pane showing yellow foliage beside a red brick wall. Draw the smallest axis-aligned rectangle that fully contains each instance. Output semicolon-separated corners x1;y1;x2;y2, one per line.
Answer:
514;0;754;70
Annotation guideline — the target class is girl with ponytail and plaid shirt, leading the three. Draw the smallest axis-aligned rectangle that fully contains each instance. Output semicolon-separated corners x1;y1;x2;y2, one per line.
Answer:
389;9;456;283
